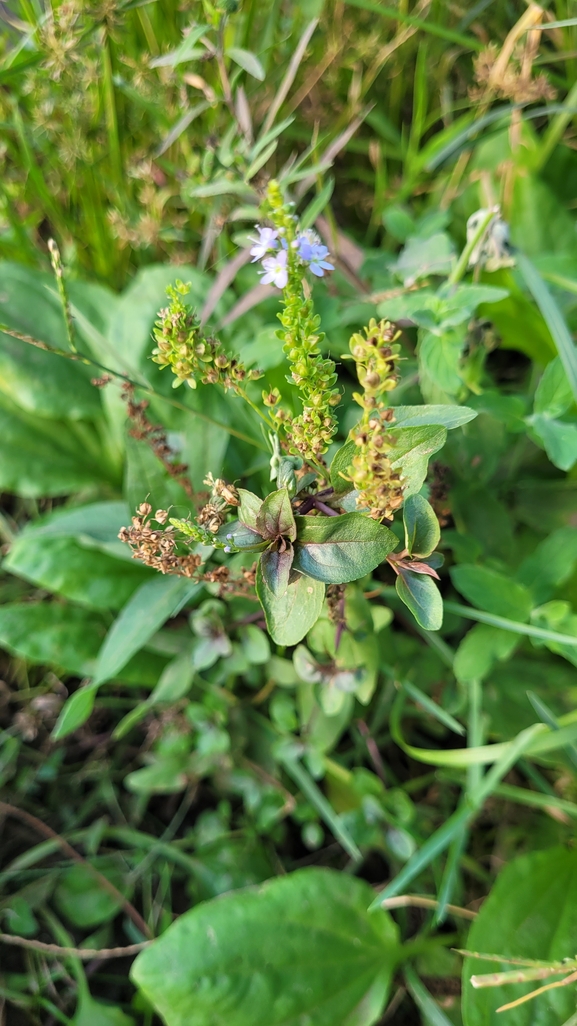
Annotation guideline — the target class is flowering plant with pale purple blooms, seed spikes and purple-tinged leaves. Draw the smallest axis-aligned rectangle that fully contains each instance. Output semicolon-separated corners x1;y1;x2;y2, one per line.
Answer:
114;181;464;644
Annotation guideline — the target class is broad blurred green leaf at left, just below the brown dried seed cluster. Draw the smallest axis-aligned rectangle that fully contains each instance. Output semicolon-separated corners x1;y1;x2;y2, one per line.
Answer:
3;530;153;609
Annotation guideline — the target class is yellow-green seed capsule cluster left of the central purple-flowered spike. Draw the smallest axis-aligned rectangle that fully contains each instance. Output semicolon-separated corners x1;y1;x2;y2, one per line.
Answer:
152;280;262;391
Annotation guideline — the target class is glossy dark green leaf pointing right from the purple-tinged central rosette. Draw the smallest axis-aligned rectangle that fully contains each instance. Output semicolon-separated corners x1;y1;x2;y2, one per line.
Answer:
293;513;398;584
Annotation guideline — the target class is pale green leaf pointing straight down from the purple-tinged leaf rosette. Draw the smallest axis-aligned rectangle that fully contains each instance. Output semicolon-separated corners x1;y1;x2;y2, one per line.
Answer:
257;562;324;645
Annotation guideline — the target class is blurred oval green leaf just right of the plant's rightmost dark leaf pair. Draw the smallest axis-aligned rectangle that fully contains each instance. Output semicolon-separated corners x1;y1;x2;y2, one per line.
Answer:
450;563;533;623
